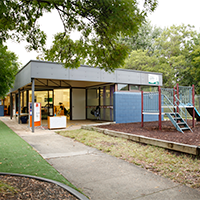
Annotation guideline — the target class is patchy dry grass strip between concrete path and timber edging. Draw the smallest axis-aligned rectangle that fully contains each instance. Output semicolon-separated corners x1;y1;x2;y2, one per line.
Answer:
57;129;200;189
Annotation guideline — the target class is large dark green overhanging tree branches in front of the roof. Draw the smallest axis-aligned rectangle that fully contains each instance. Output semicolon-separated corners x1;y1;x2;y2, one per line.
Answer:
0;0;157;70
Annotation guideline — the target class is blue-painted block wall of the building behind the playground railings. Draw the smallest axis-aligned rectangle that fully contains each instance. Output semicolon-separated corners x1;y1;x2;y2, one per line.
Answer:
113;92;161;123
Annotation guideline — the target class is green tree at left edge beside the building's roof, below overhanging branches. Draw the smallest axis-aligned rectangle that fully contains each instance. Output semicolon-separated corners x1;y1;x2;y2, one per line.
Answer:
0;45;19;98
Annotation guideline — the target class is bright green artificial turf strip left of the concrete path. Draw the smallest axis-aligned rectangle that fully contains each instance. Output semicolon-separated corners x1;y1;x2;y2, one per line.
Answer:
0;121;77;190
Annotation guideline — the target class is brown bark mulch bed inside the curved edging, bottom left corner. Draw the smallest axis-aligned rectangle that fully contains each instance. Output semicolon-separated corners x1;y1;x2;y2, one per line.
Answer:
0;175;77;200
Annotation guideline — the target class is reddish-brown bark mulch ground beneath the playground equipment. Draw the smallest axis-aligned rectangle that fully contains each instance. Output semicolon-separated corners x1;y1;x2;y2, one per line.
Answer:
99;120;200;146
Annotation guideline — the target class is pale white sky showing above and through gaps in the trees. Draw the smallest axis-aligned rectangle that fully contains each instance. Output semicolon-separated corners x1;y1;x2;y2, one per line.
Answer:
7;0;200;66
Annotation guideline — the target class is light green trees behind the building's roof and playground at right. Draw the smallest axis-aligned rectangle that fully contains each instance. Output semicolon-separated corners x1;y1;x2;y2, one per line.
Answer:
124;25;198;87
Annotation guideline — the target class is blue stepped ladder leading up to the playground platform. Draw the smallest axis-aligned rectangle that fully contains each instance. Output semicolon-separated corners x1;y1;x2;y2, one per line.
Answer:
166;112;192;133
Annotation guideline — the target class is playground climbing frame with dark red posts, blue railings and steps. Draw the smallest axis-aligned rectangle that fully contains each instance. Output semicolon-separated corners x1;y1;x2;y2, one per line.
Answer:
141;84;196;133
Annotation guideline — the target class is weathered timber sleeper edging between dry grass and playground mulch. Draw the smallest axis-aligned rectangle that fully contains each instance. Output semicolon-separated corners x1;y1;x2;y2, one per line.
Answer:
81;123;200;156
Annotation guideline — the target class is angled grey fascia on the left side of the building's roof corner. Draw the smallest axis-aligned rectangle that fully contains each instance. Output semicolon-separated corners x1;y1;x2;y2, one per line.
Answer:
10;63;31;92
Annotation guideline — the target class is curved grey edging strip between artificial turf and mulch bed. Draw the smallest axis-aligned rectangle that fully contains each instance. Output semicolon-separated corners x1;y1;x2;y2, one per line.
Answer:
0;172;89;200
